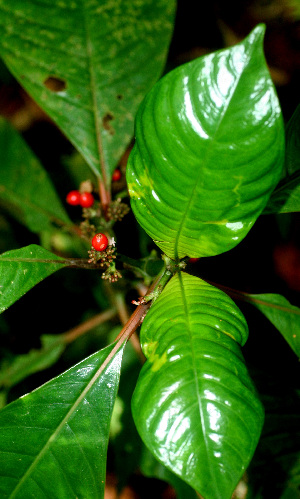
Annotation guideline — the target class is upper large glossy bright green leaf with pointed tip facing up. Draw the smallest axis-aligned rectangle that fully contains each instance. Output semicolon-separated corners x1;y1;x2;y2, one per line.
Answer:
127;26;284;258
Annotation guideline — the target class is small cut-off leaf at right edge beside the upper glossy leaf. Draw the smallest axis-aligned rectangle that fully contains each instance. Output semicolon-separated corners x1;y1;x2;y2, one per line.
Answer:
263;172;300;215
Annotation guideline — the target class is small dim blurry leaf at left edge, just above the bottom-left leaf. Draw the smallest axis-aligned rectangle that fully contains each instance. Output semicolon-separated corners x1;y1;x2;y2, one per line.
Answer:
0;334;65;388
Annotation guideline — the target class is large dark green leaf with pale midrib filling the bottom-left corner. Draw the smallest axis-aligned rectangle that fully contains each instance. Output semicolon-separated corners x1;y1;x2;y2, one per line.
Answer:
0;345;122;499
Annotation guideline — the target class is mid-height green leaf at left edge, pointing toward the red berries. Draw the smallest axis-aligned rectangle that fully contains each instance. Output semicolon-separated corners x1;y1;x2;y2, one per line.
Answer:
0;244;68;313
